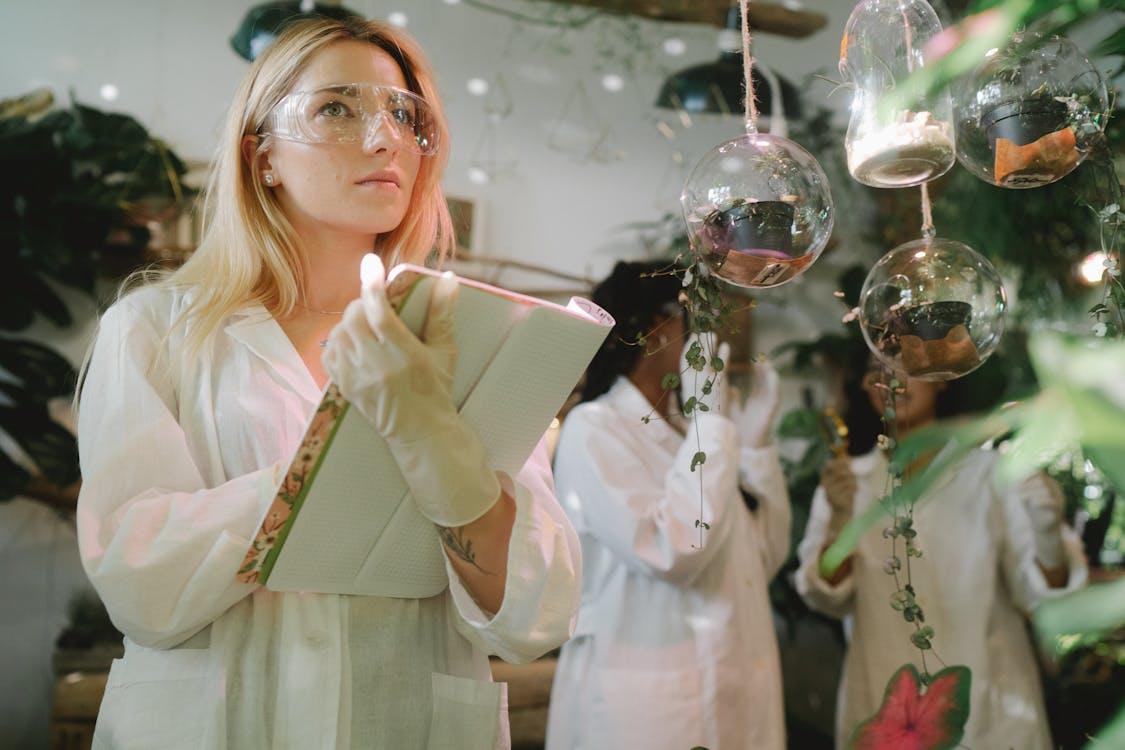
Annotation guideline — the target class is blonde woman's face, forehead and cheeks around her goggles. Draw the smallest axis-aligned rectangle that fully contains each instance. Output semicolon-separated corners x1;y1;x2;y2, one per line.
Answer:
262;40;423;240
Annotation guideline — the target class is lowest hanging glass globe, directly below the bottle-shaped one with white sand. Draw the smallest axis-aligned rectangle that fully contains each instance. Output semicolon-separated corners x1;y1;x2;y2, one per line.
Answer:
860;238;1008;380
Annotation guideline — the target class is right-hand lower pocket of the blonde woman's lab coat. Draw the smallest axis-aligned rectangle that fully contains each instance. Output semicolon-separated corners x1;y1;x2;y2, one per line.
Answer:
426;672;511;750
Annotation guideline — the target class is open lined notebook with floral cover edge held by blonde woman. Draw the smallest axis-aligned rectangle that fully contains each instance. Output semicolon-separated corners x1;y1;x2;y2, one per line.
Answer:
231;264;613;598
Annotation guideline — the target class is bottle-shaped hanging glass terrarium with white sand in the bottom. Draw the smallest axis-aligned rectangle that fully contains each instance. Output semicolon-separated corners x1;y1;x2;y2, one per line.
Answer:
839;0;955;188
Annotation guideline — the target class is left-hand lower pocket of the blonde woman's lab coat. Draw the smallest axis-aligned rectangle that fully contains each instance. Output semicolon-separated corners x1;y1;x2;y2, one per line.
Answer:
93;645;215;750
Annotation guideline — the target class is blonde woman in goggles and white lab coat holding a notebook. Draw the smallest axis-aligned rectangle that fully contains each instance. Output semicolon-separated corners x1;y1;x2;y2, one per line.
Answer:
79;20;578;750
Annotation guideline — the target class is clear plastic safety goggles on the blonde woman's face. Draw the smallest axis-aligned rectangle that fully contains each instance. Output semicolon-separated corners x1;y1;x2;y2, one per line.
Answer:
259;83;438;156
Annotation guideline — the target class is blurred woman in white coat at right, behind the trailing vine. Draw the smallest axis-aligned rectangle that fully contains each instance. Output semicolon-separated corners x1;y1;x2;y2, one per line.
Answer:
797;359;1087;750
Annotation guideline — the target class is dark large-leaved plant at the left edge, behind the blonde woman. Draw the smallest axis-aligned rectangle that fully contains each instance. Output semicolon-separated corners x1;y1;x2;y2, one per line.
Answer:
0;98;187;500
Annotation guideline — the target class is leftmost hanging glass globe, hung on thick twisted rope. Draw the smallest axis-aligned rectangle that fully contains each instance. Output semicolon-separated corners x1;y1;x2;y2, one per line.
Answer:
680;133;834;288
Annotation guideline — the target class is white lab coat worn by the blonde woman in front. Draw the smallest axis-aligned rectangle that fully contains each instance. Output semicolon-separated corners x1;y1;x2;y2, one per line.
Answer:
78;288;581;750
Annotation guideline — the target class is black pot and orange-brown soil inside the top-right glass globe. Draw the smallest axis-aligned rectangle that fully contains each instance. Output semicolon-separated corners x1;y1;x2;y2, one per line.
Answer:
981;97;1079;188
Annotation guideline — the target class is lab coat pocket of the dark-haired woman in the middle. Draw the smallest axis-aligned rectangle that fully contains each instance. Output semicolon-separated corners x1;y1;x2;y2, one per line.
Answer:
583;668;709;750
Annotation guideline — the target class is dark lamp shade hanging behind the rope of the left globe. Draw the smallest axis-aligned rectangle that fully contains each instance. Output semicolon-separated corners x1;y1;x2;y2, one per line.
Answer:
656;52;801;119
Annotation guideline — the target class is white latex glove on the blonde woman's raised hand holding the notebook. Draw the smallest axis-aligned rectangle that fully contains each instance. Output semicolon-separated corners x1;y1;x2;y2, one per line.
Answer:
324;255;501;527
